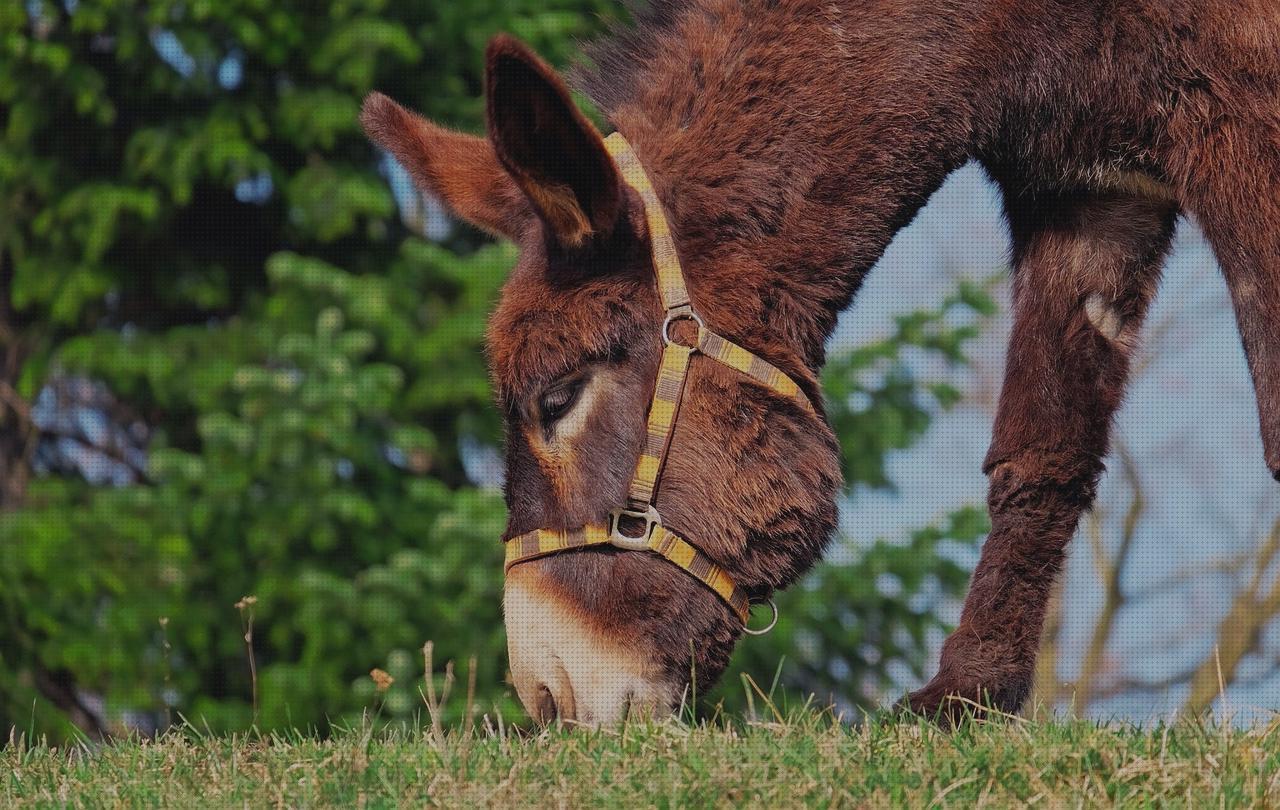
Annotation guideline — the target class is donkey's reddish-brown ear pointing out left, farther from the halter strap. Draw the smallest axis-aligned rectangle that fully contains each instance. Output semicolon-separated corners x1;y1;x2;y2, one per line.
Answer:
360;92;534;241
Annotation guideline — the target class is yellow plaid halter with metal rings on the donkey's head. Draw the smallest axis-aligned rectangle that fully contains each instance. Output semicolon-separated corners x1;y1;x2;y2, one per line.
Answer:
504;132;815;633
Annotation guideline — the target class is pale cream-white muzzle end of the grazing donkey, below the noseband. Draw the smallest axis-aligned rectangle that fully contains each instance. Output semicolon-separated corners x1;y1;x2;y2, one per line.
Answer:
503;566;680;728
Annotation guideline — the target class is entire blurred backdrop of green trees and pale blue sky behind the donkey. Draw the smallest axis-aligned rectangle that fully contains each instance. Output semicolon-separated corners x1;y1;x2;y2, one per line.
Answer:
0;0;1280;737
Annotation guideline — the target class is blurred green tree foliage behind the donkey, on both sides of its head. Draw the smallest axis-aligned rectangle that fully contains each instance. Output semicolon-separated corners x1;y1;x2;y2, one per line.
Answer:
0;0;989;735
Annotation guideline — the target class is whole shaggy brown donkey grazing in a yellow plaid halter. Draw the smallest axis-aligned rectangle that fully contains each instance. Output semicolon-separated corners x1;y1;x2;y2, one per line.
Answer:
362;0;1280;723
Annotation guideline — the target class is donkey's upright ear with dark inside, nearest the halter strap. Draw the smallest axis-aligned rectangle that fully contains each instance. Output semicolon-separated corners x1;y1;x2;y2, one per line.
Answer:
486;35;622;247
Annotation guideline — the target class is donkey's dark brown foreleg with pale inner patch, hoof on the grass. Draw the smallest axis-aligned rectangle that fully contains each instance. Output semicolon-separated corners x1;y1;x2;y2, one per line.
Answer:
908;183;1176;720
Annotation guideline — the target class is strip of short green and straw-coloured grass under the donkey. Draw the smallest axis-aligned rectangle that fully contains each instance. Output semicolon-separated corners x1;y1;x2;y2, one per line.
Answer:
0;715;1280;807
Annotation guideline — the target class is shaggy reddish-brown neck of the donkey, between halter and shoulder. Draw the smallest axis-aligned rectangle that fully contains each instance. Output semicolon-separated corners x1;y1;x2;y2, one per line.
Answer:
584;0;995;372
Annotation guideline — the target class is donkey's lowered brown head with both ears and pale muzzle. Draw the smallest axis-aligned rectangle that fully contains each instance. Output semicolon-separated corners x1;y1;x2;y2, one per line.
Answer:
361;37;840;723
